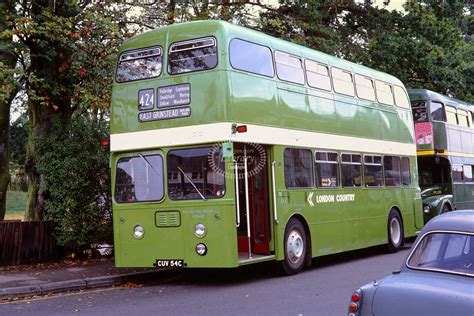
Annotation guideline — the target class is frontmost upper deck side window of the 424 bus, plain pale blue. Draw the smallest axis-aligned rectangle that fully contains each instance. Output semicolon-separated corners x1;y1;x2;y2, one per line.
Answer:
229;38;274;77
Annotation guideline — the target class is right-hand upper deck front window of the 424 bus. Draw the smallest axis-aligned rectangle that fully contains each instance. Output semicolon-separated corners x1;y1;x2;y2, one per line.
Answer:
168;37;217;75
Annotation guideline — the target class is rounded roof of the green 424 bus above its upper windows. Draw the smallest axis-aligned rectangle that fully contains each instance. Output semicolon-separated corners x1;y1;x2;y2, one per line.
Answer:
121;20;403;86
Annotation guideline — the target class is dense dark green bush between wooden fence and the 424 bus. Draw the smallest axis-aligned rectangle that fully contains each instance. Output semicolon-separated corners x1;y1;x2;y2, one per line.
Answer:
37;115;112;251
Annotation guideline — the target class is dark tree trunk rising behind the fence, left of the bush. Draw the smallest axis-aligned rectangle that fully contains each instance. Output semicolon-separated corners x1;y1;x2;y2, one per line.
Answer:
25;0;73;221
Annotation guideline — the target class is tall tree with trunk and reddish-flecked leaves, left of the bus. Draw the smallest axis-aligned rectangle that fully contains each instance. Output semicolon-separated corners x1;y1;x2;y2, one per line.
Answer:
2;0;131;220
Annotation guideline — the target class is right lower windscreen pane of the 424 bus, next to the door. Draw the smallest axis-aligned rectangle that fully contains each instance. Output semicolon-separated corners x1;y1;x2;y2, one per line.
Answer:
167;147;225;200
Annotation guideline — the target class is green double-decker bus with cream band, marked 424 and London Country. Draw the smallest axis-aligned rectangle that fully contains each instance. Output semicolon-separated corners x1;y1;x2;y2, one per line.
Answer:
110;21;423;274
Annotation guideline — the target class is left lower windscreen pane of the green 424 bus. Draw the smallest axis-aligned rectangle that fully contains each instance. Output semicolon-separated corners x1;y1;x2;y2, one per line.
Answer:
114;154;164;203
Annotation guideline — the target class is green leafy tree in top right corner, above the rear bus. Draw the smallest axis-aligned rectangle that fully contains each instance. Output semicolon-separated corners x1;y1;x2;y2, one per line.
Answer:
345;0;474;102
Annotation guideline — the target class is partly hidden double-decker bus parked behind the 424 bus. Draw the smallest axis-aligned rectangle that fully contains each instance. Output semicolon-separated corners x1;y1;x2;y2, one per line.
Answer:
408;89;474;222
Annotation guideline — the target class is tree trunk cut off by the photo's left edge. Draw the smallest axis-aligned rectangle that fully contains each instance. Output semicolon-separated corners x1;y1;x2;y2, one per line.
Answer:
0;0;18;221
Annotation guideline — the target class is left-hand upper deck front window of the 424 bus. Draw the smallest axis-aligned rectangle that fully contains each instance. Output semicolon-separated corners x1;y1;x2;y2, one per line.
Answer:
115;46;163;83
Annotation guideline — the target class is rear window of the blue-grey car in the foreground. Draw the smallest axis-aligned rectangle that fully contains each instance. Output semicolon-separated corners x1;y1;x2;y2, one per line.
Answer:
407;232;474;276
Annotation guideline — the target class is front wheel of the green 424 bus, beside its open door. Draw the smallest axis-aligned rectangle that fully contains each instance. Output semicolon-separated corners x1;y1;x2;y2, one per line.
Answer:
282;218;308;275
